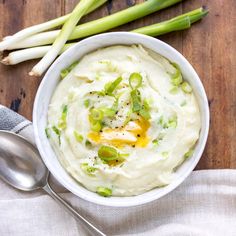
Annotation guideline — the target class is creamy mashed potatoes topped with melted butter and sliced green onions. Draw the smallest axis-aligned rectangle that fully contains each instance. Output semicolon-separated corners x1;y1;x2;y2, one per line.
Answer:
46;45;200;196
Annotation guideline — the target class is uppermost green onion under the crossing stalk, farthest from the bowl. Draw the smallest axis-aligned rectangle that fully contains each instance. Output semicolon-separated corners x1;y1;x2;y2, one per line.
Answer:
0;0;107;51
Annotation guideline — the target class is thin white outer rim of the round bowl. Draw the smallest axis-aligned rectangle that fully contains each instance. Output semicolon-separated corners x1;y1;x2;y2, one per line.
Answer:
33;32;210;207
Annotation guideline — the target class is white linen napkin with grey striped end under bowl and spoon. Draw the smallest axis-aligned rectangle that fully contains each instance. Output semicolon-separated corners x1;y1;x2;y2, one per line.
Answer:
0;105;236;236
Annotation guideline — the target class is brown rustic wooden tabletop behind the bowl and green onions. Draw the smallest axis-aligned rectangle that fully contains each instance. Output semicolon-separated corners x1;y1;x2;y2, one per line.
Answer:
0;0;236;169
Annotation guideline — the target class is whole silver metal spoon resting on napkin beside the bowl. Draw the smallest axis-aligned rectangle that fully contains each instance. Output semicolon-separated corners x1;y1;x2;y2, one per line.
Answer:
0;131;106;236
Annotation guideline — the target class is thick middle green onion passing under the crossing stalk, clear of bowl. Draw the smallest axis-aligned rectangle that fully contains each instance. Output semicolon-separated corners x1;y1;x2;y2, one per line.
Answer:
5;0;182;50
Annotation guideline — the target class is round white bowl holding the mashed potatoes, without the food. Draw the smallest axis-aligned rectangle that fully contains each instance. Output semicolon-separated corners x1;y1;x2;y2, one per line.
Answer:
33;32;209;207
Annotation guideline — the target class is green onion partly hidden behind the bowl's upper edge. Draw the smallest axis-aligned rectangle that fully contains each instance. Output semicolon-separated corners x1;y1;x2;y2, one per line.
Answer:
2;7;208;65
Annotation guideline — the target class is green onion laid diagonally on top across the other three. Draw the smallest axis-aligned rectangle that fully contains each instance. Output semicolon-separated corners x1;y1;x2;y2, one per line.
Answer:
29;0;96;76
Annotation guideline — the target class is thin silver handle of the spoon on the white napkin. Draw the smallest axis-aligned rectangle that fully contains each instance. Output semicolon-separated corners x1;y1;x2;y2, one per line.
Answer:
43;183;106;236
